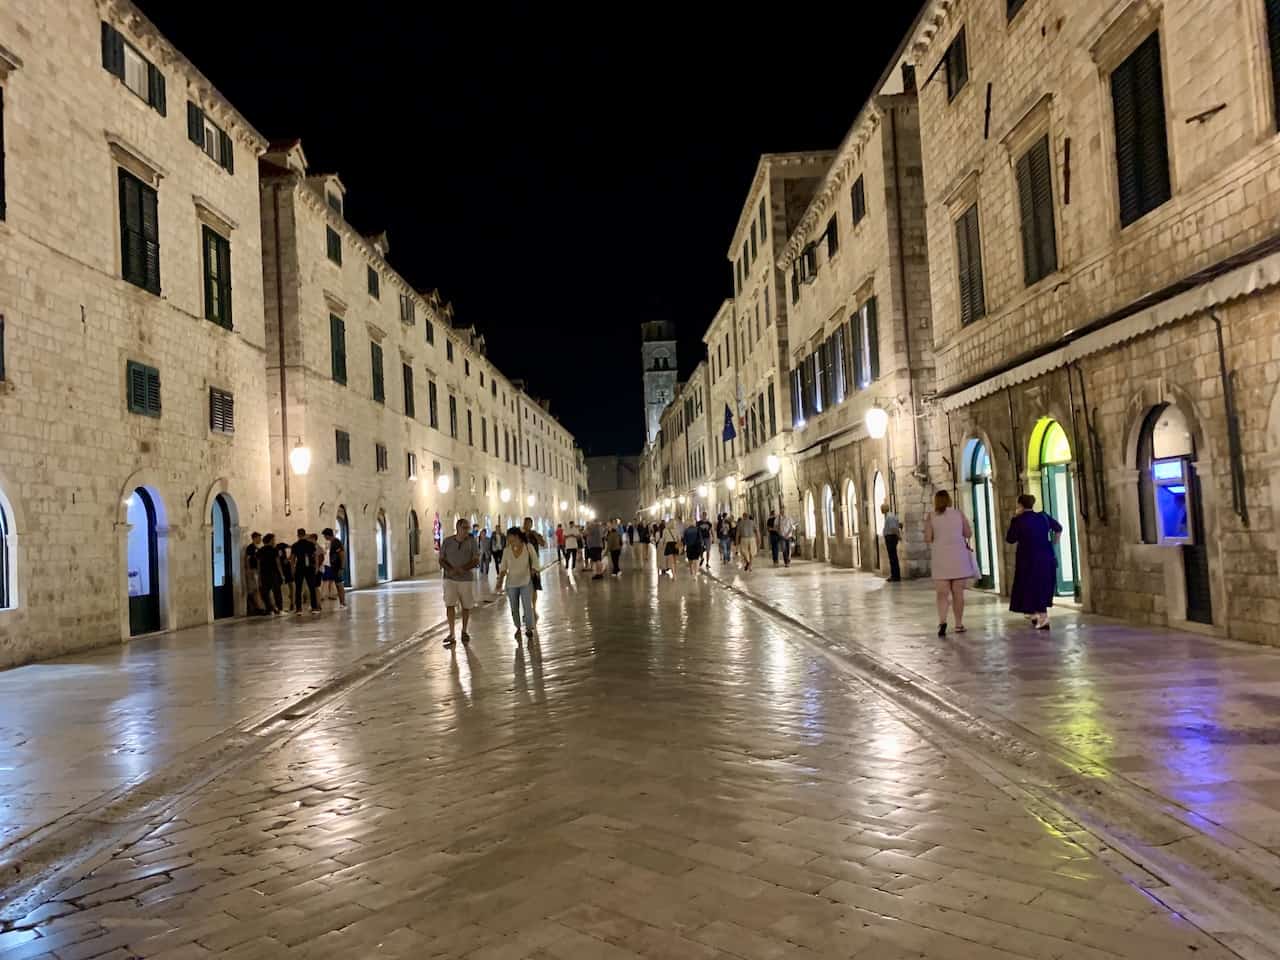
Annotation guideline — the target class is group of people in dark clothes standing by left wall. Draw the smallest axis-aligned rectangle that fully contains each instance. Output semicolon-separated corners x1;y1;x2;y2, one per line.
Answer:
243;527;347;617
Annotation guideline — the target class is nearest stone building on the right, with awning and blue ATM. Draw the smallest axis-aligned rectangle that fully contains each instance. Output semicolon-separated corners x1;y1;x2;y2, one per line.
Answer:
909;0;1280;644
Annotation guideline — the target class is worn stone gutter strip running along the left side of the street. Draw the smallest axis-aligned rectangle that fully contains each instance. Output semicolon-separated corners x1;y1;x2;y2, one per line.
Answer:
0;602;490;932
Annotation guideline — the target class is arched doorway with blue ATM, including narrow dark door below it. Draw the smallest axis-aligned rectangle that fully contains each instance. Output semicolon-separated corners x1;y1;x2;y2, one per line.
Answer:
1138;403;1213;623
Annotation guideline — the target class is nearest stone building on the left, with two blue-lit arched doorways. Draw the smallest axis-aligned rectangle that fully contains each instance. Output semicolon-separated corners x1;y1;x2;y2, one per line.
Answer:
0;0;271;667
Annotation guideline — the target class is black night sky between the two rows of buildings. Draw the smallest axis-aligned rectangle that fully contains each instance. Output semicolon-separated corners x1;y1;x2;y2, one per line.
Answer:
138;0;919;453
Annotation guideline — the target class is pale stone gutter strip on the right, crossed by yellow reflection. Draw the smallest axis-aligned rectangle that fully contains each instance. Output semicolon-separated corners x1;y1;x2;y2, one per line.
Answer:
705;571;1280;957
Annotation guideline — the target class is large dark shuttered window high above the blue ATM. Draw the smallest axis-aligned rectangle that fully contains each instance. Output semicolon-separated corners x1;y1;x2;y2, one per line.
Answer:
1111;33;1171;227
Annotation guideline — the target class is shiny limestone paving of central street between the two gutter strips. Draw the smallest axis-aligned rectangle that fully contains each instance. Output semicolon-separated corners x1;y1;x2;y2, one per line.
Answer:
0;548;1231;960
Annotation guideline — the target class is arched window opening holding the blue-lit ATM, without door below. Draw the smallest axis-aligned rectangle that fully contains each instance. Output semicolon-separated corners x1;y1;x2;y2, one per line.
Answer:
1138;403;1196;544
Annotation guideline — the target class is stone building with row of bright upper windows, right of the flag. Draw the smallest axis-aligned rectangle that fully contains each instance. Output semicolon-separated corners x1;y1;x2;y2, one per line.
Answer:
777;69;933;576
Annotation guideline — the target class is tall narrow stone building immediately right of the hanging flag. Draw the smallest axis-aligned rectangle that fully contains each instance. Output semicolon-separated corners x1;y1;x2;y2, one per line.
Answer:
707;152;832;529
